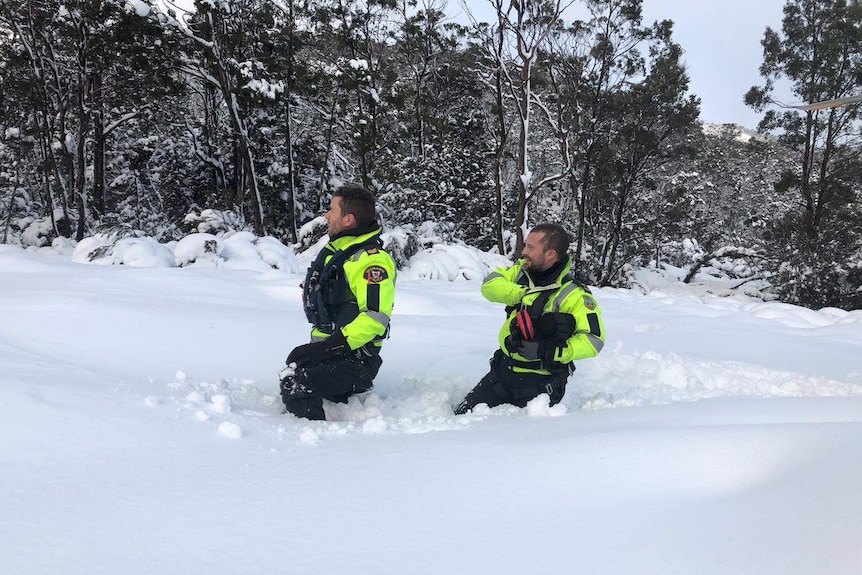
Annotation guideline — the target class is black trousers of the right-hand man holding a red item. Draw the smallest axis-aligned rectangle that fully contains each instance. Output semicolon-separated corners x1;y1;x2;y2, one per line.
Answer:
455;350;569;415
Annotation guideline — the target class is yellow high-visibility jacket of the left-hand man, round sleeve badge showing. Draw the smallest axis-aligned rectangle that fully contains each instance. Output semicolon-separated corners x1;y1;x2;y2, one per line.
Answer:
304;228;396;349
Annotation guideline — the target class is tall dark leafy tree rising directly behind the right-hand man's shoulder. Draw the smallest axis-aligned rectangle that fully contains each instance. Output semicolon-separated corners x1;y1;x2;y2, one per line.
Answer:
535;0;699;283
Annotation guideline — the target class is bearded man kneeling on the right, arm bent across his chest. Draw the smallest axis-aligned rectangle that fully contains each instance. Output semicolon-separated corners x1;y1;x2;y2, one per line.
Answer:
455;224;605;414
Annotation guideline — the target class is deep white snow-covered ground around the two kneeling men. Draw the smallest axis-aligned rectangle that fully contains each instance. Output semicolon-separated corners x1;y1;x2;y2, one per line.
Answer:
0;238;862;575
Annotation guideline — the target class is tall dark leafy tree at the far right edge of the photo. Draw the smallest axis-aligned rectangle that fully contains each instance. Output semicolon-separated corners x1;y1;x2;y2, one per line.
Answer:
745;0;862;306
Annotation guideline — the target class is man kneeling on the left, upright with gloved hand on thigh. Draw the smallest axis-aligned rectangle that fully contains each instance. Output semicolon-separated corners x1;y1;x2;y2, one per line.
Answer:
280;185;395;419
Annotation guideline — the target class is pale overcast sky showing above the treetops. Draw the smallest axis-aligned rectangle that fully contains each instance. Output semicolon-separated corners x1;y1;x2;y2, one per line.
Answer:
450;0;796;129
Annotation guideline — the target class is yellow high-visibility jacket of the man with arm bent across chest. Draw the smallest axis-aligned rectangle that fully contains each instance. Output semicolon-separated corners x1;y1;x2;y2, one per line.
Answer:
482;258;605;374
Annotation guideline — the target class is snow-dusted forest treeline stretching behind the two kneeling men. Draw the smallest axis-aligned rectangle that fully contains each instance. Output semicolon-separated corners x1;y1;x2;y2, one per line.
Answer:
0;0;862;309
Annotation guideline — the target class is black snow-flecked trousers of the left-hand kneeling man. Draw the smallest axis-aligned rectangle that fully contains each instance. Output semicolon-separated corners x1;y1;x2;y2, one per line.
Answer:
281;351;383;419
